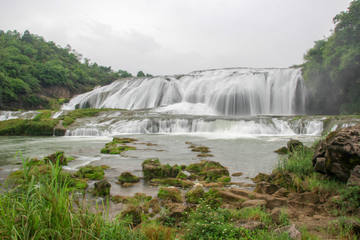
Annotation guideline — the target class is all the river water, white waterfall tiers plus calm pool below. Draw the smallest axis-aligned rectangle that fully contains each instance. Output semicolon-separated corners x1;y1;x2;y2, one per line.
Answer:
0;68;354;196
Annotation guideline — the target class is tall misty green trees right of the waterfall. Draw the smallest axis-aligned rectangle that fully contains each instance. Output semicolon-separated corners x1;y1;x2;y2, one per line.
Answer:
303;0;360;114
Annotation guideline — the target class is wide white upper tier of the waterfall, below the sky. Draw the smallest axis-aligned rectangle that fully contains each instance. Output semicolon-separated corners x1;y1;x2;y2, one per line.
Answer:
63;68;306;116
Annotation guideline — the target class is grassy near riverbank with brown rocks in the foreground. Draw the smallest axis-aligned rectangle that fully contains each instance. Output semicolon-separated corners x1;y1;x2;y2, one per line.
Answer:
1;129;357;239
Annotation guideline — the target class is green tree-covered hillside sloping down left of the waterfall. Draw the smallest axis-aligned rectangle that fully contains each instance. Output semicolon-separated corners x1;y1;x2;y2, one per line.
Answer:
0;30;151;110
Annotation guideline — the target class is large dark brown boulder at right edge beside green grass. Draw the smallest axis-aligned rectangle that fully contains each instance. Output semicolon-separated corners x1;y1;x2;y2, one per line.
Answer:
312;125;360;182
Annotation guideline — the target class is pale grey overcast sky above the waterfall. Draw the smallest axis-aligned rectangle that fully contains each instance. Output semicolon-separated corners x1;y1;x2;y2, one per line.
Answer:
0;0;351;75
